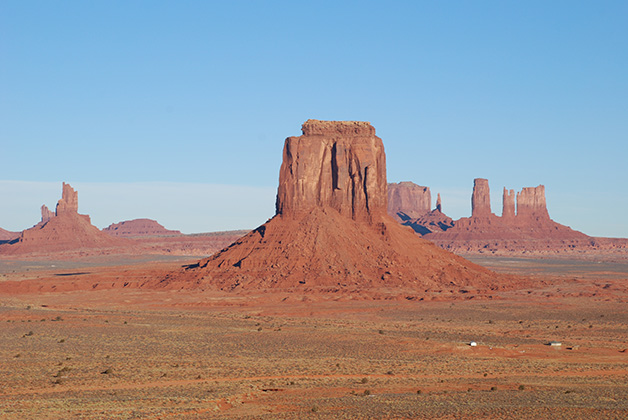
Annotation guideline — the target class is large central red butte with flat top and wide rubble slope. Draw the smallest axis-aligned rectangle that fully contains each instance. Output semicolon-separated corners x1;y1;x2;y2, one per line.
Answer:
155;120;503;291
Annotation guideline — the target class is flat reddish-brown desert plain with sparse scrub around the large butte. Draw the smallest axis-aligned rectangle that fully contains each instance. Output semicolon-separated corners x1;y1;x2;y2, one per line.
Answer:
0;254;628;419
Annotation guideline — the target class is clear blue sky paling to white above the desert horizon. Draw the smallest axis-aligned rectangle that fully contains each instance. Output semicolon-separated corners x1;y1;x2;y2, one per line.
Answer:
0;0;628;237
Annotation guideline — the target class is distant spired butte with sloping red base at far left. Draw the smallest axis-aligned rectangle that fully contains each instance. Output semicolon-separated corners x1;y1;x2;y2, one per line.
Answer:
0;183;126;255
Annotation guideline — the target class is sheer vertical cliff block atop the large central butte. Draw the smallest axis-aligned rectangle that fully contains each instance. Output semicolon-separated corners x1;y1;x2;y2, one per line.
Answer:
276;120;386;221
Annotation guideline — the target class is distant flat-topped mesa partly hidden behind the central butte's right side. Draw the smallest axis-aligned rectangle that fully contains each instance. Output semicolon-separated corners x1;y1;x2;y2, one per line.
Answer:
388;182;432;221
